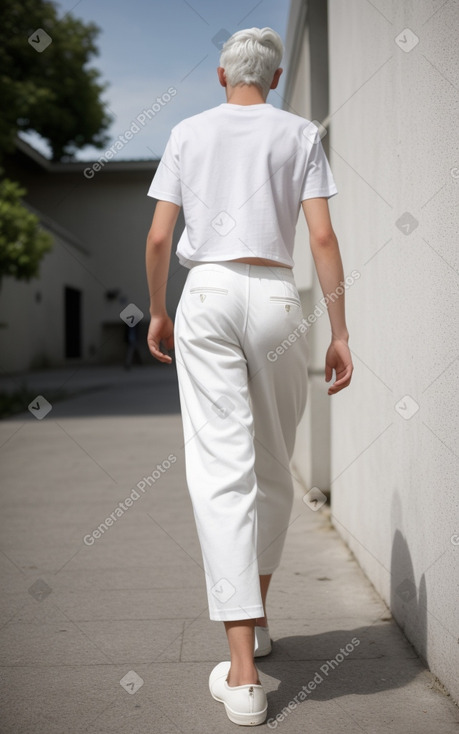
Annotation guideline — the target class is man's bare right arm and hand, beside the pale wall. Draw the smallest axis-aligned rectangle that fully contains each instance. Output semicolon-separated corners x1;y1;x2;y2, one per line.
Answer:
301;197;354;395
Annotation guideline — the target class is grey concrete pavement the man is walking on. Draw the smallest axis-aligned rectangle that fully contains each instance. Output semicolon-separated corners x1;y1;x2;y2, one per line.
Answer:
0;368;459;734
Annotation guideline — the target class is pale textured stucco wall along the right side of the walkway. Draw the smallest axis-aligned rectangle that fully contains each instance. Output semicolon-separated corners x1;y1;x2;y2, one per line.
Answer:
328;0;459;701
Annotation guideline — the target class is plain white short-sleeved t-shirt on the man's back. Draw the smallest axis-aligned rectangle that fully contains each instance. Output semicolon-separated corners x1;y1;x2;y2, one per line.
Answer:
148;103;338;267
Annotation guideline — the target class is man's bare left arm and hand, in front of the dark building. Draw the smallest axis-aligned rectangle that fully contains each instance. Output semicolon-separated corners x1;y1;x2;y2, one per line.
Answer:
145;201;180;364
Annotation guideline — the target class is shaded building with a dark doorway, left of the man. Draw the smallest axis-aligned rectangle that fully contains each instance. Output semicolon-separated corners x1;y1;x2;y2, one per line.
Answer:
0;139;186;373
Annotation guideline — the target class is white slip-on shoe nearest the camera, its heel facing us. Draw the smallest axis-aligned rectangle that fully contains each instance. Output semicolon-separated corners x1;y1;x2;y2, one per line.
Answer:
209;660;268;726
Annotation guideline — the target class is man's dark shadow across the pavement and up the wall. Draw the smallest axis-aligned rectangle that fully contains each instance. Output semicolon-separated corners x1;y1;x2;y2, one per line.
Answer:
256;494;427;726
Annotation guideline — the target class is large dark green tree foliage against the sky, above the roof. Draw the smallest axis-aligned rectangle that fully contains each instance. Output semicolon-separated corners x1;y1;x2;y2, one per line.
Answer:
0;0;111;161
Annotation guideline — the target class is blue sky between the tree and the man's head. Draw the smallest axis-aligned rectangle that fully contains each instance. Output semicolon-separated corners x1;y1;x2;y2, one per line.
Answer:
24;0;290;160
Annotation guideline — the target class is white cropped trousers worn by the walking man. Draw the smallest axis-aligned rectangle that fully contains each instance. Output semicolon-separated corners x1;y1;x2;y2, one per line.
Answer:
174;261;309;621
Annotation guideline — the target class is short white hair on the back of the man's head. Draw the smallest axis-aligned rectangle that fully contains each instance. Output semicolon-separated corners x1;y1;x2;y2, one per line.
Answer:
220;28;284;99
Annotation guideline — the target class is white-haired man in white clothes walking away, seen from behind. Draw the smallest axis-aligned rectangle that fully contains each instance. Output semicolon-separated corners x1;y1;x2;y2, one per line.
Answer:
146;28;353;725
